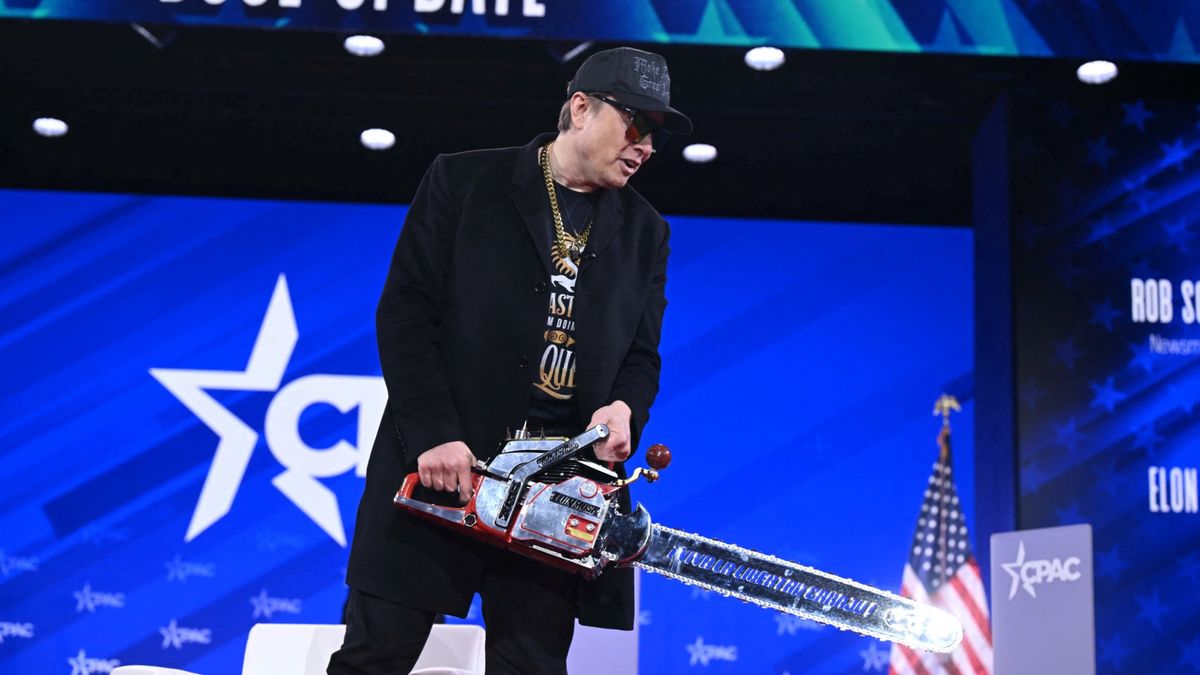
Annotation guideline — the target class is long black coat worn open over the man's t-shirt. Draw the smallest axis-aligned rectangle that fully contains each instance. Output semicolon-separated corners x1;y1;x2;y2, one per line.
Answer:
347;135;668;629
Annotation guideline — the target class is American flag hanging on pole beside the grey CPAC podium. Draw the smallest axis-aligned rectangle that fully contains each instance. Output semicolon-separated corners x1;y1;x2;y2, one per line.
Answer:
888;426;991;675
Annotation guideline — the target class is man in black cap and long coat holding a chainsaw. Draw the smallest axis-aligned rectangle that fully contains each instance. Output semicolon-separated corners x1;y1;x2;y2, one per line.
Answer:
329;48;691;675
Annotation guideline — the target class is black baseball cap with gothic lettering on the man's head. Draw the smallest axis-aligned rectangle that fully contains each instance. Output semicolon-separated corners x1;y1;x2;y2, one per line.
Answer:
566;47;691;136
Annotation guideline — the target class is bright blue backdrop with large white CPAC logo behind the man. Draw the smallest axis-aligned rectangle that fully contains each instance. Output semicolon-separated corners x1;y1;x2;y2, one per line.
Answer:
0;184;974;674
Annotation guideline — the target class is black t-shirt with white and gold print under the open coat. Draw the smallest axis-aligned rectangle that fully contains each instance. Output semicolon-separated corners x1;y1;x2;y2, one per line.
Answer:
529;186;598;435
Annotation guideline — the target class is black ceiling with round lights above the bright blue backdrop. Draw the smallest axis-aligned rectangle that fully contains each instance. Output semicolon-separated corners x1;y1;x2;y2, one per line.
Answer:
0;20;1161;225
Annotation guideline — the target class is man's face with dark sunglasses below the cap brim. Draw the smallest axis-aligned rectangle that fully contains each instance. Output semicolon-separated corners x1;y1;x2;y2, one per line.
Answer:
580;96;662;189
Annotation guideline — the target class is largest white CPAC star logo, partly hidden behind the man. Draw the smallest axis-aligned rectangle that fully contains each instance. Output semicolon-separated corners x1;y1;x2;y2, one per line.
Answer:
150;274;388;546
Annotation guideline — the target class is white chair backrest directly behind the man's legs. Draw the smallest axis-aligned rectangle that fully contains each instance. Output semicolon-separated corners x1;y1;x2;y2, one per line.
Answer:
241;623;485;675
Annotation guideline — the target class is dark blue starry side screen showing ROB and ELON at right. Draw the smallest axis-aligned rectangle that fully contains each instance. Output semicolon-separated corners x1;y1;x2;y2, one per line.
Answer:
1012;90;1200;674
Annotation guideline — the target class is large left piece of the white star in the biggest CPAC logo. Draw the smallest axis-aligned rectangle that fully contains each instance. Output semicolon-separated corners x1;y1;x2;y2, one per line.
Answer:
150;274;300;545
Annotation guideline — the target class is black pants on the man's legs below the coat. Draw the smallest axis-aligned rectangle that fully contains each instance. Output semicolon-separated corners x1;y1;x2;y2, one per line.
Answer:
328;550;578;675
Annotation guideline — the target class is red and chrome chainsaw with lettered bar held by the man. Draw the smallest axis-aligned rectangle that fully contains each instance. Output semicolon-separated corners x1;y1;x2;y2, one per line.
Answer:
395;424;962;652
